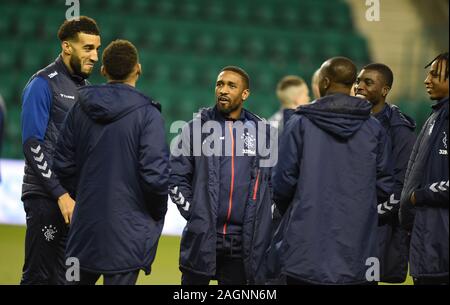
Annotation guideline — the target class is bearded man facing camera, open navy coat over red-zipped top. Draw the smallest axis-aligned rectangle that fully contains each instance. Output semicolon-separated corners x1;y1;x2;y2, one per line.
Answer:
169;66;272;285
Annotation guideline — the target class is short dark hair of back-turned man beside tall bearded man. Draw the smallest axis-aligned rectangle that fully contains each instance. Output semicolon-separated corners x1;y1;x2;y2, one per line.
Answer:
102;39;138;81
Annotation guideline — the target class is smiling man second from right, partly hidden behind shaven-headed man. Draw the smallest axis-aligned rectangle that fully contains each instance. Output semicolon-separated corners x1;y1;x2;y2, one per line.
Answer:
354;63;416;283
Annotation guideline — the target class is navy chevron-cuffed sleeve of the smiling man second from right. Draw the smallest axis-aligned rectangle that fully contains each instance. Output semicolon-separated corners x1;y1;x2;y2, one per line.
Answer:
378;126;416;225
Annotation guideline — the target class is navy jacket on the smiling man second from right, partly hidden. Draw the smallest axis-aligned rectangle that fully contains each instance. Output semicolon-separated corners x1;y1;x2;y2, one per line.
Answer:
374;104;416;283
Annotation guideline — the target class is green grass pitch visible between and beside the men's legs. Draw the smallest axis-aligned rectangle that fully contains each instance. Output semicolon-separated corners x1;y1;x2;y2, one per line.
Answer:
0;225;412;285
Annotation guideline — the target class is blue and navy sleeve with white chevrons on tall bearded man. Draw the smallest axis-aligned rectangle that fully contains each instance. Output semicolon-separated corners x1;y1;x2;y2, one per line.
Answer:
21;77;66;199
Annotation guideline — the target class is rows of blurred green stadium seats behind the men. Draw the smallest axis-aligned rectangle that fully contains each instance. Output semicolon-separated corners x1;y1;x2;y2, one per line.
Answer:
0;0;370;157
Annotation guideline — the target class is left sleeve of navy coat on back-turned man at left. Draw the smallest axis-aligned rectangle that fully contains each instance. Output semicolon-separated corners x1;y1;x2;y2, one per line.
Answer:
53;106;77;198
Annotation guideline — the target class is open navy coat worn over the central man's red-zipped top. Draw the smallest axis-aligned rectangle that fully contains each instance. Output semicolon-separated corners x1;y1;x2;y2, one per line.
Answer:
170;108;272;284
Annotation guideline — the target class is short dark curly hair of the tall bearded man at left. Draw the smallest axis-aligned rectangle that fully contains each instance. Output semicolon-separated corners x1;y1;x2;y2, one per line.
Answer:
58;16;100;41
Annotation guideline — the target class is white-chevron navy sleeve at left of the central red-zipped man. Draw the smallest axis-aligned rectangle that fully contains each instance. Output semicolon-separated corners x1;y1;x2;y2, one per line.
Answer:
169;124;195;220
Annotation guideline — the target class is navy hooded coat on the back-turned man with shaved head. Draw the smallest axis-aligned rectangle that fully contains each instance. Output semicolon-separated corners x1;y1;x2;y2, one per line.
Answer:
273;94;393;284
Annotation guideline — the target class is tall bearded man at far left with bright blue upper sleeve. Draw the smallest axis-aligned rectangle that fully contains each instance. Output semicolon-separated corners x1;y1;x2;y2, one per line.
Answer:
21;16;100;285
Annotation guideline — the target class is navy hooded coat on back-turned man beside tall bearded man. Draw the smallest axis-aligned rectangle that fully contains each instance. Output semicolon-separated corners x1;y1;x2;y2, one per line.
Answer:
54;83;169;273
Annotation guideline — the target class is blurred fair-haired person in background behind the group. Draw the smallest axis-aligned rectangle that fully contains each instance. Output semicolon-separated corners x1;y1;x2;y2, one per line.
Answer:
269;75;310;132
